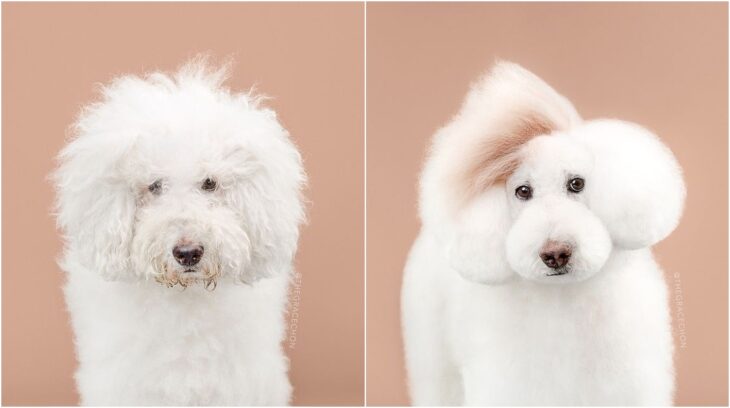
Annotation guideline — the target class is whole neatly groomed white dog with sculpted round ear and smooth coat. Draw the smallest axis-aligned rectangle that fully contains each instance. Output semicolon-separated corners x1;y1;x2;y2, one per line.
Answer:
402;63;685;405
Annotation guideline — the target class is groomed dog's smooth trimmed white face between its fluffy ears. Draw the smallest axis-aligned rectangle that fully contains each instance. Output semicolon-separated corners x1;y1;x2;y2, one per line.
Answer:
505;135;611;283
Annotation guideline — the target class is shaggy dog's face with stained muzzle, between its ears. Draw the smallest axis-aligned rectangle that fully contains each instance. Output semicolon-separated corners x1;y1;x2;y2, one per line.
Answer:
124;130;267;286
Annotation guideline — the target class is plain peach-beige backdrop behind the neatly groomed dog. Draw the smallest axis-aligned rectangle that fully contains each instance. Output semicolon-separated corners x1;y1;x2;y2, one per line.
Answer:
367;3;728;405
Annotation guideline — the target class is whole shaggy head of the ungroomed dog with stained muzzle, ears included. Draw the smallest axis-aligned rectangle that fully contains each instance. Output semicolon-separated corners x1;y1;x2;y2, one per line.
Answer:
53;59;305;287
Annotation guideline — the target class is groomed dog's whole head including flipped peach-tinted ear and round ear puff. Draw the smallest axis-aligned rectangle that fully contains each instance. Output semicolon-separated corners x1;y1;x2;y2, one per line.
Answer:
421;63;685;283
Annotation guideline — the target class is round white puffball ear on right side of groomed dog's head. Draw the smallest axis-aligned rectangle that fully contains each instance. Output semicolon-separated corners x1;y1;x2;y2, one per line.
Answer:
575;120;686;249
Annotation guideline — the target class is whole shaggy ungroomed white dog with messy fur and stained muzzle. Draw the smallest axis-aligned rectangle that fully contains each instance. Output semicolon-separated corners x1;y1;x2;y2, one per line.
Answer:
54;59;305;405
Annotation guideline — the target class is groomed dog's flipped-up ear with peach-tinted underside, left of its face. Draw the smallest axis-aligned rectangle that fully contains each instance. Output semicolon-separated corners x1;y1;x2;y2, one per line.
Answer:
420;62;581;283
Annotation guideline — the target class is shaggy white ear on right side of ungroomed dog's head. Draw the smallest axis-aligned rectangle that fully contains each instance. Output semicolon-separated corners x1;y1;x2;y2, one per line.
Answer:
227;109;307;283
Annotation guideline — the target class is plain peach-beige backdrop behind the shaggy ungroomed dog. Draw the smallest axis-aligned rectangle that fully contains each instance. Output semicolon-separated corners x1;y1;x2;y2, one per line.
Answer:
2;3;364;405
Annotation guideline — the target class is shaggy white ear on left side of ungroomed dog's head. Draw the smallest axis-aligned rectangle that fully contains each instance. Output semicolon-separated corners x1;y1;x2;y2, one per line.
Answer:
52;131;136;280
